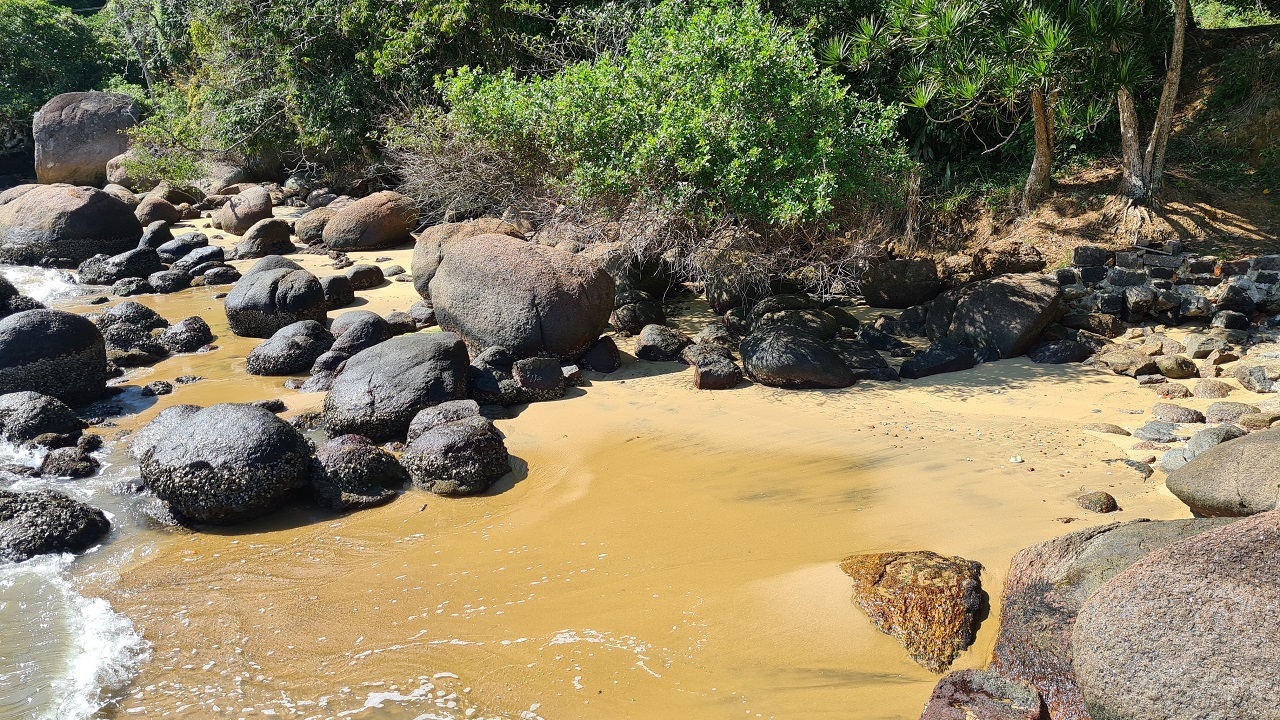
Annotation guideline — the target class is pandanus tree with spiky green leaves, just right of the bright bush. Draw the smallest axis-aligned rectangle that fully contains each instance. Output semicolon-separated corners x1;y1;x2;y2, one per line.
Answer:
819;0;1097;211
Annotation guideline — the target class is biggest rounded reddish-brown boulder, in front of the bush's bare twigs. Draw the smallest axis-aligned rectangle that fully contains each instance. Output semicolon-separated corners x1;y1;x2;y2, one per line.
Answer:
430;234;614;359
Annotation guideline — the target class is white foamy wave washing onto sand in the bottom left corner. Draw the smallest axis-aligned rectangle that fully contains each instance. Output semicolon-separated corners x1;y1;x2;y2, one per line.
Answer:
0;553;150;720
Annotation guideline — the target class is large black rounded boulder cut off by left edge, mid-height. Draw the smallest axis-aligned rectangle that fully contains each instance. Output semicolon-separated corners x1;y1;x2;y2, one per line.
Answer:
0;309;106;405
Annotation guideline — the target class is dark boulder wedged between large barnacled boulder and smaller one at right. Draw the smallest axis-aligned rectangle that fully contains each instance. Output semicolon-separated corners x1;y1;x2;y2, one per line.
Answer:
311;436;408;512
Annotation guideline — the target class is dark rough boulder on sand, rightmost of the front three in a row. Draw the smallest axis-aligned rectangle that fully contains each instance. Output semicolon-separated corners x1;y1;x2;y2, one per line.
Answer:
401;416;511;496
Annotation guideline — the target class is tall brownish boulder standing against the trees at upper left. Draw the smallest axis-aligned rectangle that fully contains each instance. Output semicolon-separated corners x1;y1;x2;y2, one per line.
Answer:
31;92;140;187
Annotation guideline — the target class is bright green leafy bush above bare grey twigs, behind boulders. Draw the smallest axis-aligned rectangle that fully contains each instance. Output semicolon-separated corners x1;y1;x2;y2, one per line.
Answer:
440;0;908;227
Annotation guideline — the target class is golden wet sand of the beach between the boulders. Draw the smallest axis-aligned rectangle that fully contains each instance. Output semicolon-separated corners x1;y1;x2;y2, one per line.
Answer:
62;212;1218;720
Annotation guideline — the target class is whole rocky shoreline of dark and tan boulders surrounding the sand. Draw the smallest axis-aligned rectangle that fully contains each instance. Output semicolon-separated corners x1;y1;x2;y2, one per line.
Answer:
0;90;1280;720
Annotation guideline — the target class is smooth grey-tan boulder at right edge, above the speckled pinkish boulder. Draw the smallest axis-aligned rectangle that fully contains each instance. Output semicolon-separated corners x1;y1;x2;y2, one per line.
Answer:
1165;430;1280;518
